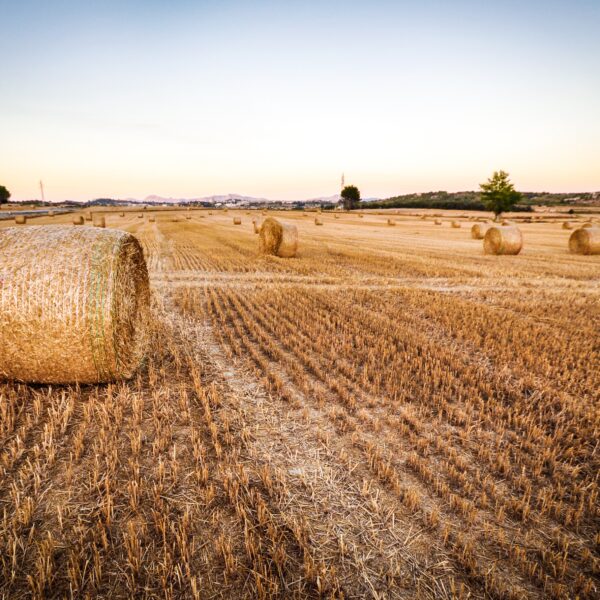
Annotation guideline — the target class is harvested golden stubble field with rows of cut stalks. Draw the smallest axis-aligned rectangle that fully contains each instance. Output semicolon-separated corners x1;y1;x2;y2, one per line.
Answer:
0;210;600;599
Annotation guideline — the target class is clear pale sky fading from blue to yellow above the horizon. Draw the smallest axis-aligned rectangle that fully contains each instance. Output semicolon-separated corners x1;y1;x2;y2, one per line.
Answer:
0;0;600;201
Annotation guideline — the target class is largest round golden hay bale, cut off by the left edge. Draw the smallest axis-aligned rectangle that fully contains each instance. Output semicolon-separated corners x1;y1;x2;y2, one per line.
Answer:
0;225;149;383
